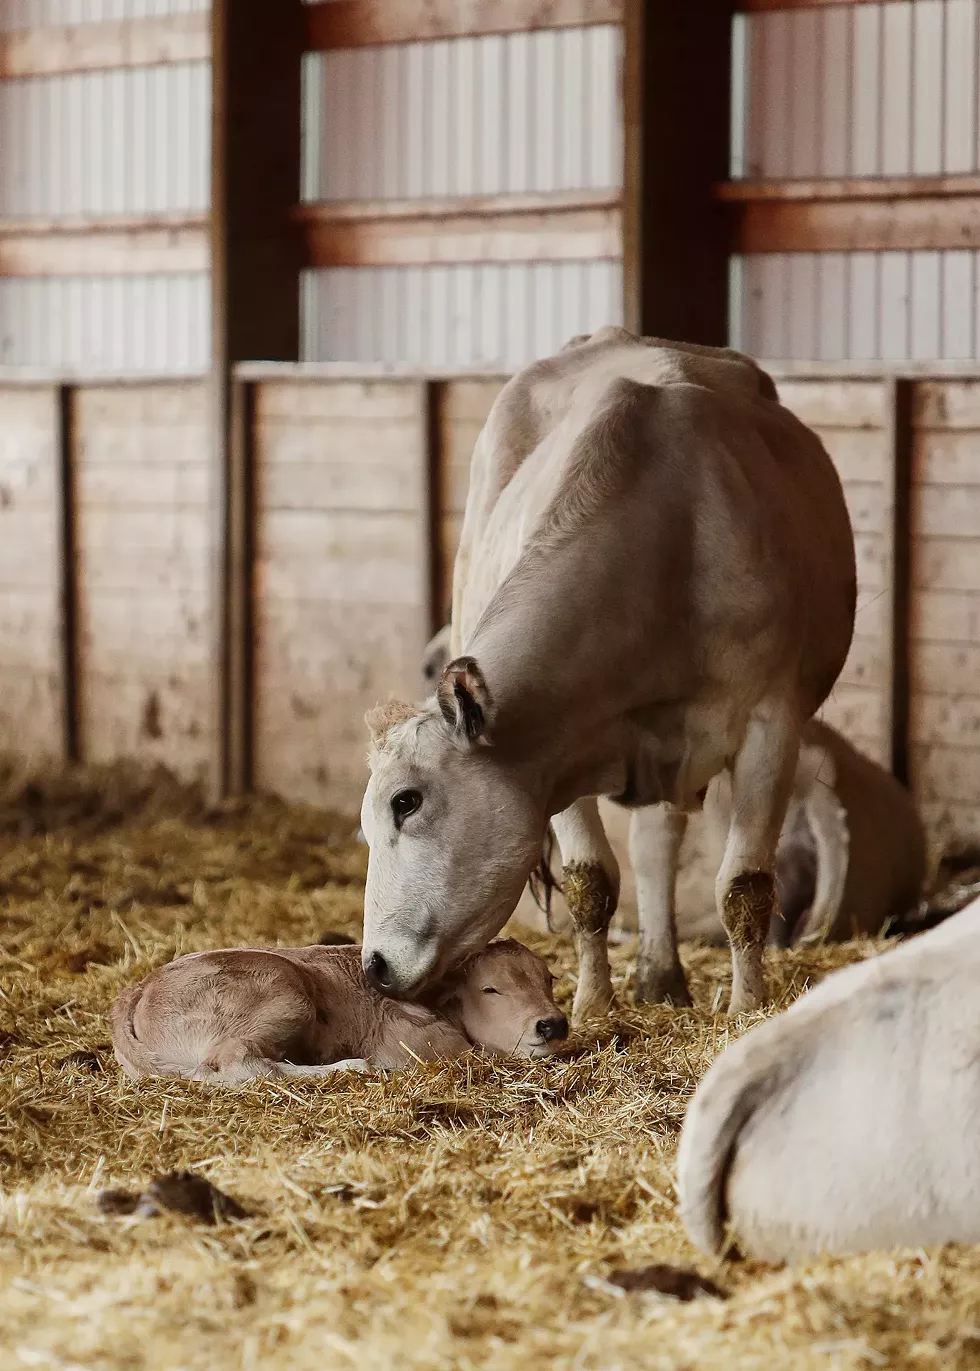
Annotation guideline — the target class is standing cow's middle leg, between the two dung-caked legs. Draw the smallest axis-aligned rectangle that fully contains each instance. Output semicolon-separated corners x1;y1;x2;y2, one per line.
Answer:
629;805;691;1006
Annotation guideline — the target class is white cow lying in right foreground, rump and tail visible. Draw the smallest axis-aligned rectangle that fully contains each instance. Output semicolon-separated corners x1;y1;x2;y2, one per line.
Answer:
677;899;980;1260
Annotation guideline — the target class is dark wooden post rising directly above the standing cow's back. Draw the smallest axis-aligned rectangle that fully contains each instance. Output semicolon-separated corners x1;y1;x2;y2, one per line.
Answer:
622;0;736;345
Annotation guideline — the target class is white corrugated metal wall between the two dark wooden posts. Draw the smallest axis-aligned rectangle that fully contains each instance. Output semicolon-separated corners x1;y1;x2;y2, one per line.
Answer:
303;26;622;367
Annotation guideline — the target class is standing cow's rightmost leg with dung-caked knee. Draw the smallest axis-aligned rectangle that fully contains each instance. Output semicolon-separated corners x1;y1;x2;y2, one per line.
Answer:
715;702;799;1015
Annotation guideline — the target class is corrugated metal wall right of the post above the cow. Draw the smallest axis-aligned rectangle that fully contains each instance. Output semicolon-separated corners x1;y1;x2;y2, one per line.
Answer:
732;0;980;361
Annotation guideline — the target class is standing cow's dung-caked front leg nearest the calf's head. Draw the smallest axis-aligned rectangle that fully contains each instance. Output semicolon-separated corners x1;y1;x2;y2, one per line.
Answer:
551;799;620;1023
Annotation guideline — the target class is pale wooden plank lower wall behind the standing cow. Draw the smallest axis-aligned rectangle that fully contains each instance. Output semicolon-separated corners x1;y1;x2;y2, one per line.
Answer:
0;363;980;847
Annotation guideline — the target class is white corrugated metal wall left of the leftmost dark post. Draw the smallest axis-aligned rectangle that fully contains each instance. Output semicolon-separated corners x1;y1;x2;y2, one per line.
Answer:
0;0;211;374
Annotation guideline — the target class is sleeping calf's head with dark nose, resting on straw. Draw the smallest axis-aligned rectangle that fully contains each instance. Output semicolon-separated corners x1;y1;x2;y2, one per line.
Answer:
440;938;569;1057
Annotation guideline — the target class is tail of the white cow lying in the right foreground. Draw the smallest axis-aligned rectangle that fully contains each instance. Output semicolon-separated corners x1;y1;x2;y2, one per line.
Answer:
677;1030;774;1256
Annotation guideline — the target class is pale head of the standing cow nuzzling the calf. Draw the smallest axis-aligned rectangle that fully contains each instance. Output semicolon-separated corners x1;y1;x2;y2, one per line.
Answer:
360;658;547;998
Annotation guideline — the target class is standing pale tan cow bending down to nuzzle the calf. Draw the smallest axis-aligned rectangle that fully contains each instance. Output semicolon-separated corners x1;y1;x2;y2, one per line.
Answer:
362;329;855;1019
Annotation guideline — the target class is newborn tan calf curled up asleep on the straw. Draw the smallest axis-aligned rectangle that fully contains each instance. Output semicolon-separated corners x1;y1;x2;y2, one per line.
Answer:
112;939;569;1086
